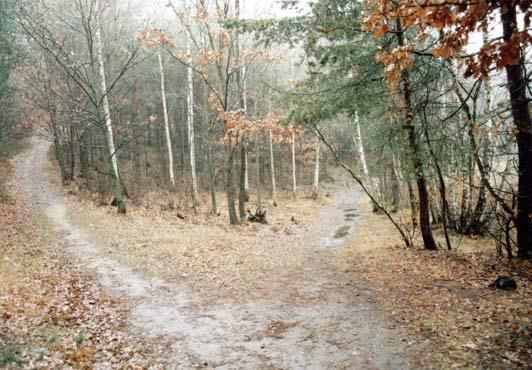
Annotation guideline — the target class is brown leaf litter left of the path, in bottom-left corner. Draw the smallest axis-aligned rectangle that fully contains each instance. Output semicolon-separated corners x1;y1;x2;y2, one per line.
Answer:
0;161;165;368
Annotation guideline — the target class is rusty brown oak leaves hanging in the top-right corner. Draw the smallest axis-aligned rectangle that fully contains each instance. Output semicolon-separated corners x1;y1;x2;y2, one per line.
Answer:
363;0;532;83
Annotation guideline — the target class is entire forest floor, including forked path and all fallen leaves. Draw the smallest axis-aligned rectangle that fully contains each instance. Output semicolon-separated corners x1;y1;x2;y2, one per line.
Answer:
0;140;532;369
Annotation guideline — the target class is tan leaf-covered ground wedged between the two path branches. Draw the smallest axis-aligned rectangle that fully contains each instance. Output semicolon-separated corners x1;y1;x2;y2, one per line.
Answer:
68;188;331;297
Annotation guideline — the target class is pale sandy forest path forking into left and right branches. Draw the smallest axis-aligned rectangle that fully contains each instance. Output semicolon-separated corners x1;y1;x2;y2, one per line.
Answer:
14;139;411;369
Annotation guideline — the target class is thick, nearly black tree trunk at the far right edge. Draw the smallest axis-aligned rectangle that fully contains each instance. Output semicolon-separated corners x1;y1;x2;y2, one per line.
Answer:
501;0;532;259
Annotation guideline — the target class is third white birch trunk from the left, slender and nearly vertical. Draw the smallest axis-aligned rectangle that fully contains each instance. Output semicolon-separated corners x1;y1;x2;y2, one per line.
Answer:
186;25;198;209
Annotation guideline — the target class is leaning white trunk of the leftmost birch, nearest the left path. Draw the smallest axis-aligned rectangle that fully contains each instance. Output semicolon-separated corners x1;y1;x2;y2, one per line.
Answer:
94;0;126;213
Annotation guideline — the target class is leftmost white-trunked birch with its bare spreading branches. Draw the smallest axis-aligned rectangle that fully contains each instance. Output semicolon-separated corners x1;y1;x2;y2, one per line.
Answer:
16;0;138;213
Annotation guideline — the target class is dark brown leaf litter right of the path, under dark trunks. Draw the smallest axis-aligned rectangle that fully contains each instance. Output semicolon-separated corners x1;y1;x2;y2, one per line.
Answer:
333;215;532;368
